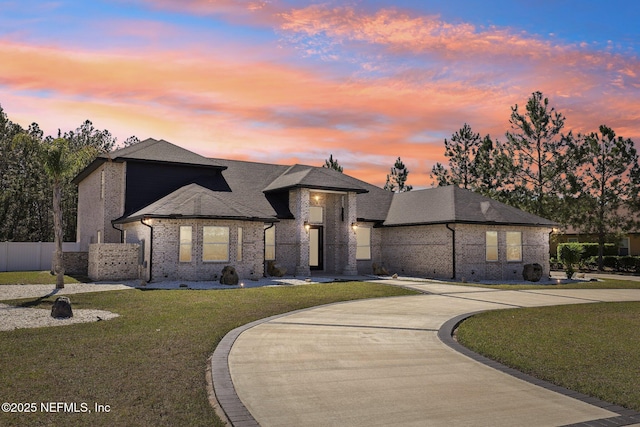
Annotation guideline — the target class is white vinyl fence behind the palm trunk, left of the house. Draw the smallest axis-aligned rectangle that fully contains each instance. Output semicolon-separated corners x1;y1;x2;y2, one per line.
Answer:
0;242;80;271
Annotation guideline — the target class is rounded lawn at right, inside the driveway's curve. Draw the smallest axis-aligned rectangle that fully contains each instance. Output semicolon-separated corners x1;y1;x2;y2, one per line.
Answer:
457;302;640;411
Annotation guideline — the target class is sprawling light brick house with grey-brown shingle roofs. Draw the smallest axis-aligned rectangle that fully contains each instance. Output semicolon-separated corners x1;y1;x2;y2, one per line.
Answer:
74;139;555;281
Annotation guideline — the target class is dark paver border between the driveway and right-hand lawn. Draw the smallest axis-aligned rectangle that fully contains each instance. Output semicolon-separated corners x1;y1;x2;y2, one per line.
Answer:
438;310;640;427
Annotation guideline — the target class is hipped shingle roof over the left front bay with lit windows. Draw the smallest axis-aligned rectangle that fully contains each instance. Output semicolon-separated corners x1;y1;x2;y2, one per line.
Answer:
115;184;275;223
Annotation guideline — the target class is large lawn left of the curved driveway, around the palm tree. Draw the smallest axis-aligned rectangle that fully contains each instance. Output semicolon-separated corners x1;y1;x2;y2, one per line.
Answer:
0;282;415;426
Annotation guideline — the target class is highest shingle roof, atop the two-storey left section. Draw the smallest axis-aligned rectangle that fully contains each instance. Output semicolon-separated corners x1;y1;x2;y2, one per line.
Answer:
73;138;226;184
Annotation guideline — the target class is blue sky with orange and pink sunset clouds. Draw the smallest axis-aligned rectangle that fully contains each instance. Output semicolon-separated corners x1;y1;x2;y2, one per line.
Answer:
0;0;640;188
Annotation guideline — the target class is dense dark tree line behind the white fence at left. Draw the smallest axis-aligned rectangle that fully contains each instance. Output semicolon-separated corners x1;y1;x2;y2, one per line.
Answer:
0;106;138;242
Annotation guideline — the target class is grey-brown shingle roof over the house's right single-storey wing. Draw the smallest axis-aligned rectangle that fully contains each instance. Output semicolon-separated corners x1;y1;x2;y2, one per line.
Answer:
383;185;557;227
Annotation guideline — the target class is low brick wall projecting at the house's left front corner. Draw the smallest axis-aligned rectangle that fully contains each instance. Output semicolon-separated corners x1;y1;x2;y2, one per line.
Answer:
89;243;140;281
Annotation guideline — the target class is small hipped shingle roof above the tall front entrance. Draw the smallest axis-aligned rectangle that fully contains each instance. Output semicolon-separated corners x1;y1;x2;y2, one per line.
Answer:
264;165;368;193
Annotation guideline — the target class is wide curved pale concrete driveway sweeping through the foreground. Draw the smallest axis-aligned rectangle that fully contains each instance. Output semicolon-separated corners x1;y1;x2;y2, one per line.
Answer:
212;280;640;427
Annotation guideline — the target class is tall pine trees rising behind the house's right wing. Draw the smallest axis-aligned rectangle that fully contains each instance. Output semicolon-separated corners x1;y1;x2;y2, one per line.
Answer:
325;91;640;268
